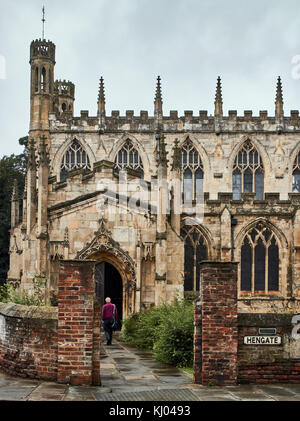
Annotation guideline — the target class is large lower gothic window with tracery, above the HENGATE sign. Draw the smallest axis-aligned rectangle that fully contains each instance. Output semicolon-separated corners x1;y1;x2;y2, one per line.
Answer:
241;223;279;294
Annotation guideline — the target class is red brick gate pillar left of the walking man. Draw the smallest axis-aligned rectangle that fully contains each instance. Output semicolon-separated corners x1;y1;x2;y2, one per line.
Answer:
57;260;100;385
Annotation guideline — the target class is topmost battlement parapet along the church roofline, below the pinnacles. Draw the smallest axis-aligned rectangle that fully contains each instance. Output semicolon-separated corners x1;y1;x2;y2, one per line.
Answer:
52;110;300;135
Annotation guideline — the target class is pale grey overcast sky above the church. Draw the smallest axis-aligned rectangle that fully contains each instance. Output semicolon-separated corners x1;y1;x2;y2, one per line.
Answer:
0;0;300;156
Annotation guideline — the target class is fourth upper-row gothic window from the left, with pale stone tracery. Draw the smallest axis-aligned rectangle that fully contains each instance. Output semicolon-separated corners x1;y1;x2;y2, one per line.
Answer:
232;140;264;200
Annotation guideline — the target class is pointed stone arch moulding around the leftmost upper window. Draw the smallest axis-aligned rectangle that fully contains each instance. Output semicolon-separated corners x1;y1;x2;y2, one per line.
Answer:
51;133;96;180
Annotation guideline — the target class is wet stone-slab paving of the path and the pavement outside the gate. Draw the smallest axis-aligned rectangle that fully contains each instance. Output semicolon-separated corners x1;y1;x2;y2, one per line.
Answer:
0;335;300;402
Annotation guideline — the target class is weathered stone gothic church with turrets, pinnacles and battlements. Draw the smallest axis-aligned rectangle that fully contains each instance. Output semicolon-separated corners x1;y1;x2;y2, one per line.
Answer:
8;39;300;318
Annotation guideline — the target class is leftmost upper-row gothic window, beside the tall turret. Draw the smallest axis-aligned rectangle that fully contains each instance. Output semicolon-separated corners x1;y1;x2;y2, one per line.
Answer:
60;139;91;181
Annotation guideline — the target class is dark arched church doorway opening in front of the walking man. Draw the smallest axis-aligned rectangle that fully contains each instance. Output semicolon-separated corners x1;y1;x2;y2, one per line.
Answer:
95;261;123;320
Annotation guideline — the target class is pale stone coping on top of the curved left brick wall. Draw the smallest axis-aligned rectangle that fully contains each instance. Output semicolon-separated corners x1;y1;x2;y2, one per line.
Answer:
0;303;58;321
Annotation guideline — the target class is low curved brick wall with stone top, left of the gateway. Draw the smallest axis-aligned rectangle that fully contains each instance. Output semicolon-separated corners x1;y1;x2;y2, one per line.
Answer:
0;303;57;380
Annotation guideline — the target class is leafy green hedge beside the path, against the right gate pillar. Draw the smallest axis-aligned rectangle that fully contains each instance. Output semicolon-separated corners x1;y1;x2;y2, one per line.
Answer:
122;299;194;367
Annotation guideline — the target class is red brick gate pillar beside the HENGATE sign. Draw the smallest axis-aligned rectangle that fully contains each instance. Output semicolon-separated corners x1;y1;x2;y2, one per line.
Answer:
194;261;238;385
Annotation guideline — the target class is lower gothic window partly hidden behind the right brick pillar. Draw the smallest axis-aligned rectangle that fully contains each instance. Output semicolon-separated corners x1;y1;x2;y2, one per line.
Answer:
181;226;208;291
